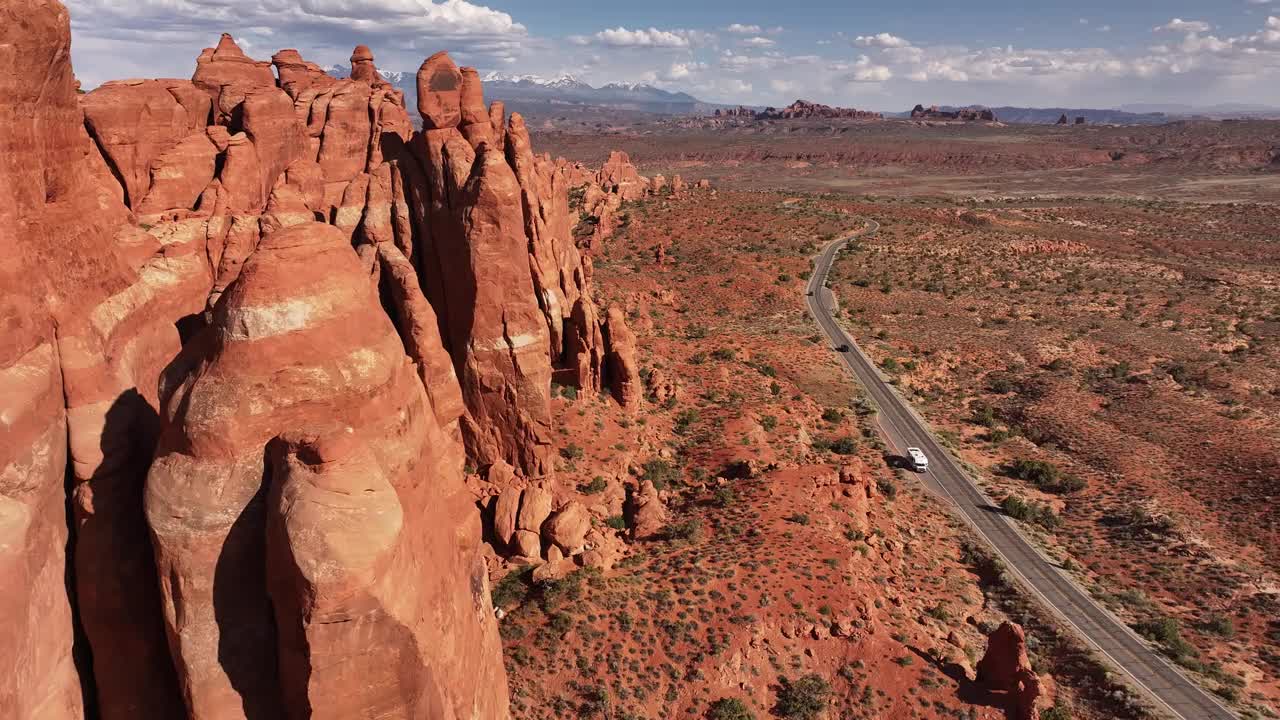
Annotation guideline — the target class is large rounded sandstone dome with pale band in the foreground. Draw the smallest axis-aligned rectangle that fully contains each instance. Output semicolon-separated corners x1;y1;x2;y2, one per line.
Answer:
146;223;506;717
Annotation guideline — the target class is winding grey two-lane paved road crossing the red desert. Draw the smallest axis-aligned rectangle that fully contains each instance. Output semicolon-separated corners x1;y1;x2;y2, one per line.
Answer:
805;222;1235;720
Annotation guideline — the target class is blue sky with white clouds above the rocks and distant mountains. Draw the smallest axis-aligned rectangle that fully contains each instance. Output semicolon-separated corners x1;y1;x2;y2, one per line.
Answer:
65;0;1280;110
